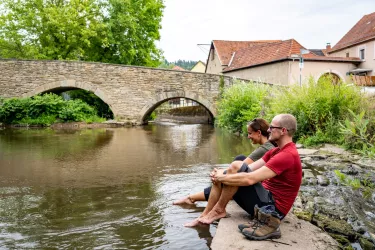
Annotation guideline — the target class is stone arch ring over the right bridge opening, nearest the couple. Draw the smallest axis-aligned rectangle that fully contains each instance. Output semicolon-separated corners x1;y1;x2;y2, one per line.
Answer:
138;91;216;124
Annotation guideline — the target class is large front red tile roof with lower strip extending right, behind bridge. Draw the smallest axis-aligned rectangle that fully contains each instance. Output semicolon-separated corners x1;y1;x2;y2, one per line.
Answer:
223;39;360;72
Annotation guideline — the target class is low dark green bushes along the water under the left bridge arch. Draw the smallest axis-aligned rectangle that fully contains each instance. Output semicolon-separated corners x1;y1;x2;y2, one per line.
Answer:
0;93;106;126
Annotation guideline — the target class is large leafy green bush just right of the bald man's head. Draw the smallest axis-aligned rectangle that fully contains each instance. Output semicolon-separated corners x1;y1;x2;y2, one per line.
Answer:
267;78;365;143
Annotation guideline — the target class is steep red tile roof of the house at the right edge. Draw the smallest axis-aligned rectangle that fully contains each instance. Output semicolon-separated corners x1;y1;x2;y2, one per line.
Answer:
328;12;375;53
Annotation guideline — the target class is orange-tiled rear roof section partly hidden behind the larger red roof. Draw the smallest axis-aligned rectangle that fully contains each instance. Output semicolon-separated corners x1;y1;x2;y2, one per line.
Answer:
212;40;281;66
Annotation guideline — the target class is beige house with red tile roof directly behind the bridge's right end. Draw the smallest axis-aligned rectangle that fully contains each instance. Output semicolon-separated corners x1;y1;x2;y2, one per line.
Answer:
206;39;361;85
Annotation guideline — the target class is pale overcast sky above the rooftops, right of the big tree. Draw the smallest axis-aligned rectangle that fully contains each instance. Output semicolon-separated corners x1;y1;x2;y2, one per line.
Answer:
158;0;375;62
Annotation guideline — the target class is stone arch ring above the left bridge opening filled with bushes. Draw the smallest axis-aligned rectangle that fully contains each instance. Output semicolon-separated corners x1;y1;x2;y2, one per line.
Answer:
22;80;118;117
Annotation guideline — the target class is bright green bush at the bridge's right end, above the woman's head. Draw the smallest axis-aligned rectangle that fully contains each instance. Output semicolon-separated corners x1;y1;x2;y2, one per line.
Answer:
216;81;270;133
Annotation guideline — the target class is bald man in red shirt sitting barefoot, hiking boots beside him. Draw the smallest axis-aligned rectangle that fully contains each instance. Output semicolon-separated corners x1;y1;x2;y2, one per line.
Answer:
185;114;302;240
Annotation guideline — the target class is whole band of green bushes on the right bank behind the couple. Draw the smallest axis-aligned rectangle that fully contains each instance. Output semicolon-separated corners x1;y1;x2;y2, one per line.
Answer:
216;77;375;157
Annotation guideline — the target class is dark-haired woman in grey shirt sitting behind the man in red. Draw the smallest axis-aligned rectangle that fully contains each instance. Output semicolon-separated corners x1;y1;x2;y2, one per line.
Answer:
173;118;275;205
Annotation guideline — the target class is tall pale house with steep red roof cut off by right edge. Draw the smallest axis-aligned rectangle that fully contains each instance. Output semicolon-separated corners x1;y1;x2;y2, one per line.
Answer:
327;12;375;85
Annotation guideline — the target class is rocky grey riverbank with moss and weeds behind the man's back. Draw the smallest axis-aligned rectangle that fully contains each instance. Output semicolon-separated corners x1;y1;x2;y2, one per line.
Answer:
293;145;375;250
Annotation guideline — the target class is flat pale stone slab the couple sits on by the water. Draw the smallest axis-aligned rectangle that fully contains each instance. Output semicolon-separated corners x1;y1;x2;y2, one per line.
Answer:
211;201;339;250
